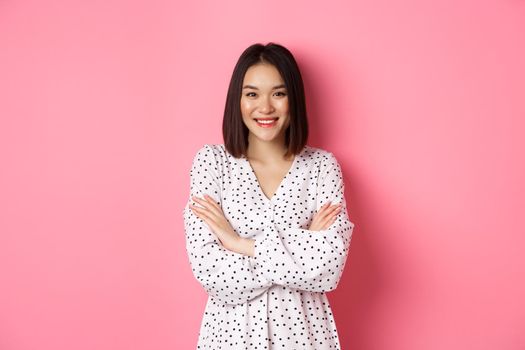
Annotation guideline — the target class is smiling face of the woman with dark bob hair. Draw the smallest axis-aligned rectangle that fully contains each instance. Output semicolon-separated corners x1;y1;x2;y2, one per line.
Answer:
241;63;290;143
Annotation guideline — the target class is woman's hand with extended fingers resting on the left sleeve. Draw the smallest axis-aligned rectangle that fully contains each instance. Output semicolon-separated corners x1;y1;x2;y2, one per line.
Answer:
190;194;242;251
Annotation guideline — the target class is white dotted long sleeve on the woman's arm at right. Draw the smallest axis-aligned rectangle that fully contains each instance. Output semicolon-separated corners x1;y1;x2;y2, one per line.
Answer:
254;153;354;292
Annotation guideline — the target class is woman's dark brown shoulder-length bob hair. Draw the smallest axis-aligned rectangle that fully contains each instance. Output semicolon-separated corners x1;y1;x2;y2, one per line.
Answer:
222;42;308;158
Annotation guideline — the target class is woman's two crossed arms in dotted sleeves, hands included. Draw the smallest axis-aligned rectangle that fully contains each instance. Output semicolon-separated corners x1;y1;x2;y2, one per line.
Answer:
183;145;354;304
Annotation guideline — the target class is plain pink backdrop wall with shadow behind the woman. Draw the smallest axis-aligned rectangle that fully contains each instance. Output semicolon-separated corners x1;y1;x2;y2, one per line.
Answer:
0;0;525;350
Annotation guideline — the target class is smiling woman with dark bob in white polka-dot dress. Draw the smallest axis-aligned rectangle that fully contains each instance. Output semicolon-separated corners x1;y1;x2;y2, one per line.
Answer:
184;43;354;350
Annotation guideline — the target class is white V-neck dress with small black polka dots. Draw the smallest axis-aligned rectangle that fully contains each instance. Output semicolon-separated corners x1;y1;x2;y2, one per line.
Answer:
183;144;354;350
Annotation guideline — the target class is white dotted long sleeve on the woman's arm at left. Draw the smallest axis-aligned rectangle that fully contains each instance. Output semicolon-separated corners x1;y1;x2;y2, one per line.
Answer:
183;145;273;305
